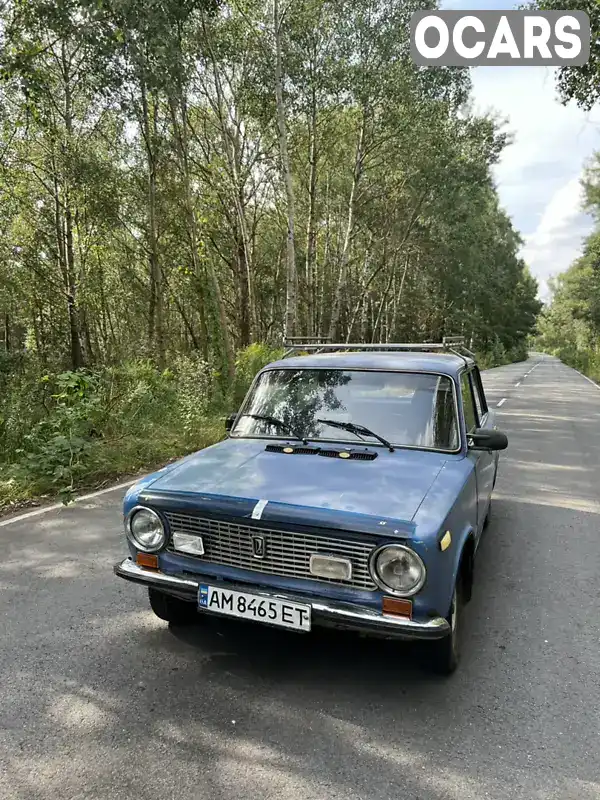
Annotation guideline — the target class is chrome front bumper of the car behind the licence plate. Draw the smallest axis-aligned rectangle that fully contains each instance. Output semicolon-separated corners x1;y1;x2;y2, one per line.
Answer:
114;558;450;639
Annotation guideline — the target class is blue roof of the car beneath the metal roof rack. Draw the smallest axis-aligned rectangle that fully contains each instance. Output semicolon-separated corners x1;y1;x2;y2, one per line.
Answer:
266;350;475;376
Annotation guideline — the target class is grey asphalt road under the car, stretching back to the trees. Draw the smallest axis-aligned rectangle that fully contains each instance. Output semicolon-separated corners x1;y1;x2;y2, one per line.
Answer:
0;356;600;800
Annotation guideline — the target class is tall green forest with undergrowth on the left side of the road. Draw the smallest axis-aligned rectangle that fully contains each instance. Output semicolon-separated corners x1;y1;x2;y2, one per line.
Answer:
0;0;544;507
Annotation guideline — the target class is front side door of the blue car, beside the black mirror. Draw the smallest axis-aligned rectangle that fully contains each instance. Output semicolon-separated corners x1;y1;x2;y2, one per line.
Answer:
461;367;497;531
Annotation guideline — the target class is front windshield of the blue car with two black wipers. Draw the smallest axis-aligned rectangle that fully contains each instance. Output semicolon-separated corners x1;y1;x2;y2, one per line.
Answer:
231;369;458;450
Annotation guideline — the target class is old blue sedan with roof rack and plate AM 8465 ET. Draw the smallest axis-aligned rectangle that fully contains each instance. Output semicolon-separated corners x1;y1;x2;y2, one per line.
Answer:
115;339;507;674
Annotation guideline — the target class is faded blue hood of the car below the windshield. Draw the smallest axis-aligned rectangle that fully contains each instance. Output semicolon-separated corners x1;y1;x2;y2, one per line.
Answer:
137;439;446;527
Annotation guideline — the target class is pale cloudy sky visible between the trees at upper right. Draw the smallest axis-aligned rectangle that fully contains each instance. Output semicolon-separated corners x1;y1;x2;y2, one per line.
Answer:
441;0;600;300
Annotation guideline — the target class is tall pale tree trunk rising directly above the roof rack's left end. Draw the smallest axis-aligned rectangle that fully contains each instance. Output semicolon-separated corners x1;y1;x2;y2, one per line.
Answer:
273;0;298;339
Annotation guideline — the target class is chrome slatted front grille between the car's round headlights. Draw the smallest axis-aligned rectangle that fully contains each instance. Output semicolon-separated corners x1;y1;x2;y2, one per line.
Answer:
165;512;377;591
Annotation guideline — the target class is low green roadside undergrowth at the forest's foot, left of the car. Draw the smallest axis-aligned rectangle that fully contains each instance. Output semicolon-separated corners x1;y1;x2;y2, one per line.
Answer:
0;344;282;507
